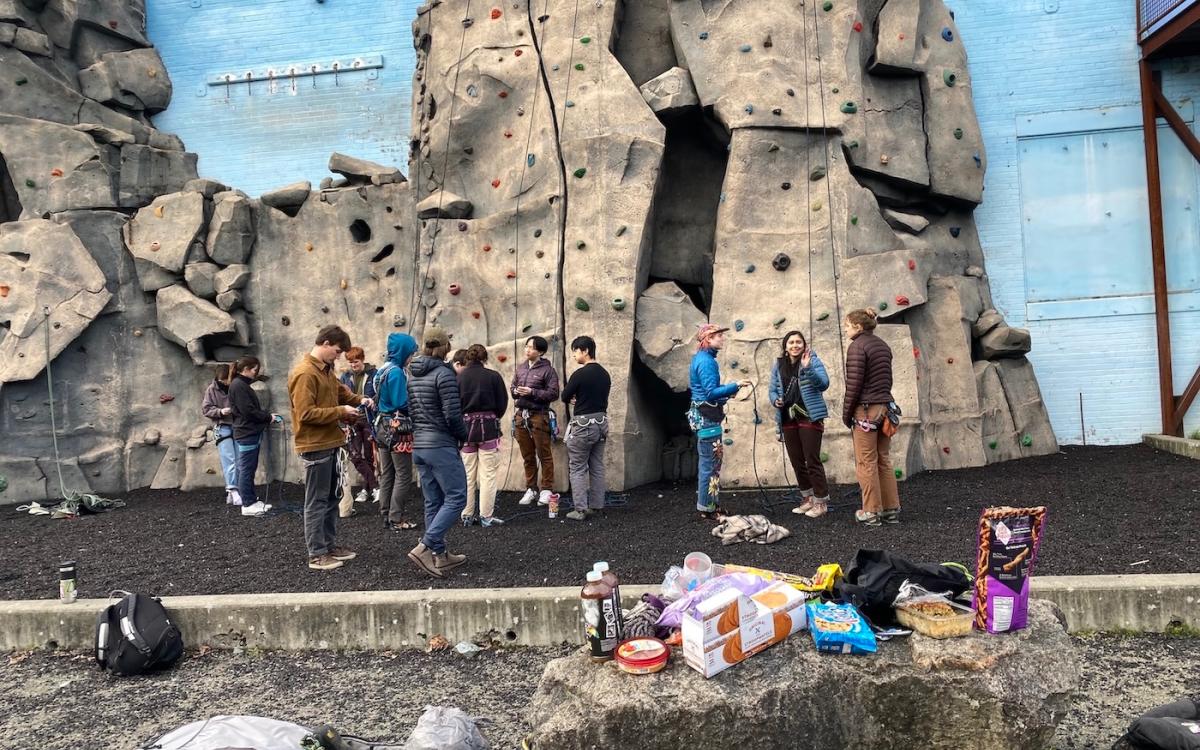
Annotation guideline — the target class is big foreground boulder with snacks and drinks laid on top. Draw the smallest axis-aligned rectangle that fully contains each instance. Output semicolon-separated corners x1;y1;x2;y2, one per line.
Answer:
528;601;1080;750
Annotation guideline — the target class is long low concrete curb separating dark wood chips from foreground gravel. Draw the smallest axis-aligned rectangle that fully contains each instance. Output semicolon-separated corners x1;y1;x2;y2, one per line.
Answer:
0;574;1200;650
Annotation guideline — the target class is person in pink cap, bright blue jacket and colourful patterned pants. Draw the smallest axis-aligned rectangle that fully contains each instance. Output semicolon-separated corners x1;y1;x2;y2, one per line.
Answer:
688;323;750;521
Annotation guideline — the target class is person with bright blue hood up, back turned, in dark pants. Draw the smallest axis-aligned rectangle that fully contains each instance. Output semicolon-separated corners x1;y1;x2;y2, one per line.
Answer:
374;334;416;532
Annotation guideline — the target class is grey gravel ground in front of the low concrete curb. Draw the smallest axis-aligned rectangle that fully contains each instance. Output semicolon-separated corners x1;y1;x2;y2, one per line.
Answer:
0;635;1200;750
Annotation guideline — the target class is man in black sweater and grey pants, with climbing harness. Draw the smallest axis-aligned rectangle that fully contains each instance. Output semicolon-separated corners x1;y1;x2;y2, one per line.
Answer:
563;336;612;521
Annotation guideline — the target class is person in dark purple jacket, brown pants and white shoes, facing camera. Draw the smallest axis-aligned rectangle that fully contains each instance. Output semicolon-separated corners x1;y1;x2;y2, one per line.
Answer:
509;336;559;505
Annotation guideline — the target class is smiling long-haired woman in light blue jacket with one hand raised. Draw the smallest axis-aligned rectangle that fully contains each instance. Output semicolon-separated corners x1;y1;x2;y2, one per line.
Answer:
768;331;829;518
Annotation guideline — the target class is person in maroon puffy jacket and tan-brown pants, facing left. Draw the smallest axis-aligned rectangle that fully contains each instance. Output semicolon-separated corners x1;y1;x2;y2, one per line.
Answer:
841;310;900;527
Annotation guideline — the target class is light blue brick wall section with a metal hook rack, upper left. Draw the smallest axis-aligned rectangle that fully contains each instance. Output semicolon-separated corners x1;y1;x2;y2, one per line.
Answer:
146;0;420;196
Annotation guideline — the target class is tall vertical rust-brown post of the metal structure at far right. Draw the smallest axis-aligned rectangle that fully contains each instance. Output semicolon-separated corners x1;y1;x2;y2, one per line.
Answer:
1138;58;1180;434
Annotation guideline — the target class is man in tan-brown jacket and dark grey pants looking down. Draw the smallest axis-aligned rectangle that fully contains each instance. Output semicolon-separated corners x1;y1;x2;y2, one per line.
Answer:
288;325;374;570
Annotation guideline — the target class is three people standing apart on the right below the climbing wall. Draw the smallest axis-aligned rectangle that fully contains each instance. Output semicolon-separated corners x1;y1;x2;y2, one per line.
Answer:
688;308;900;527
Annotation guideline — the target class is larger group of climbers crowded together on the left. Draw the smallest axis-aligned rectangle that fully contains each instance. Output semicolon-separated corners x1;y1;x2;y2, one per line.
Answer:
202;326;611;578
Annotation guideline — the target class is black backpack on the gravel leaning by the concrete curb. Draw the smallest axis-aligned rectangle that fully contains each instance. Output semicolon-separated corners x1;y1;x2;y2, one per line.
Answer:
96;592;184;676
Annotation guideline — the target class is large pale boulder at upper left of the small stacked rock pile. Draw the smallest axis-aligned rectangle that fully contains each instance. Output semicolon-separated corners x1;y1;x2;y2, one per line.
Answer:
125;193;204;274
